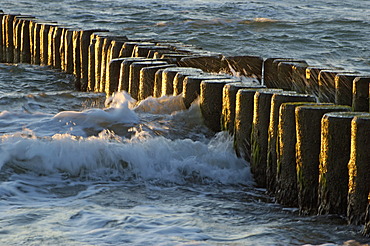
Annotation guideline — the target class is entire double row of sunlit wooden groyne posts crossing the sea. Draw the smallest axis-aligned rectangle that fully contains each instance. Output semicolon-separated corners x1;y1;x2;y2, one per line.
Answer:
0;13;370;234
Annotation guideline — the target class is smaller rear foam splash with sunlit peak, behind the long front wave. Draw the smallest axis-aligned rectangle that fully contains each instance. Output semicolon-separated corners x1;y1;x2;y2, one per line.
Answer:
48;91;185;137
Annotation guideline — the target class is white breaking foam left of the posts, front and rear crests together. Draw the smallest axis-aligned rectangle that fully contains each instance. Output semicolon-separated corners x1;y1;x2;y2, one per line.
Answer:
0;89;252;184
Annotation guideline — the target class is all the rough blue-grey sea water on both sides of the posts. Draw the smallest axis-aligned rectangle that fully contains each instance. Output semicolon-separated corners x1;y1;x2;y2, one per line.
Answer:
0;0;370;245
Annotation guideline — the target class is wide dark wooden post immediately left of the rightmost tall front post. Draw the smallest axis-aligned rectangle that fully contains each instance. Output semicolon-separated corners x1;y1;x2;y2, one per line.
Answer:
318;112;364;215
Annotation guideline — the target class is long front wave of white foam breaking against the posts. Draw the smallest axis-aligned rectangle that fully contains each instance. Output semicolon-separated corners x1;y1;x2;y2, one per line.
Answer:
0;131;252;184
